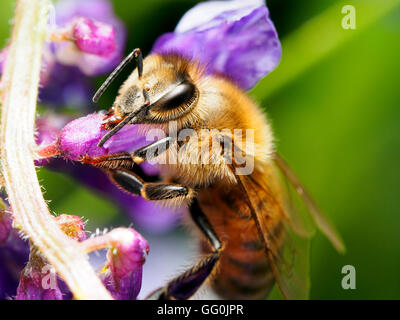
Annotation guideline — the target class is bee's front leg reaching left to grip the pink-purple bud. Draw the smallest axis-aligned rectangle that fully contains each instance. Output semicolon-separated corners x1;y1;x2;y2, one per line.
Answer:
81;137;173;169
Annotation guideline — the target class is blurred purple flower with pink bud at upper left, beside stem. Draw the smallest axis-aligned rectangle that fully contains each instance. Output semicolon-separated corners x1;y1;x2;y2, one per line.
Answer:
39;0;126;110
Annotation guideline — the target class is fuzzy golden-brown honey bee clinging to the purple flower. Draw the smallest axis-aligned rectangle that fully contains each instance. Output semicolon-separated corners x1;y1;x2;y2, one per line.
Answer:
82;49;344;299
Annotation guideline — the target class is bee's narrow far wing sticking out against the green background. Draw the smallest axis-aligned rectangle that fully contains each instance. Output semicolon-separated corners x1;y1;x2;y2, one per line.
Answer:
274;153;345;253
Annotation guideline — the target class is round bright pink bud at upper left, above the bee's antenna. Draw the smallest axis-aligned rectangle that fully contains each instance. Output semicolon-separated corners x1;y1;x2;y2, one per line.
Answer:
72;18;117;57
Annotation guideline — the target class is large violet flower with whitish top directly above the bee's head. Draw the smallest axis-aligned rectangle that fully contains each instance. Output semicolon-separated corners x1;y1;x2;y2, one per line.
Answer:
153;0;281;90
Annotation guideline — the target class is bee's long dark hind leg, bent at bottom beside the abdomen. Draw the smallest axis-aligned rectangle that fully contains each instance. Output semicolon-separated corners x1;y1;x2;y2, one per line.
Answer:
146;199;223;300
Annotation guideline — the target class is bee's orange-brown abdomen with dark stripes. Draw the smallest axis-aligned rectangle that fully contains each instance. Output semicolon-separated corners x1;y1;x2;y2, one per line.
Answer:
199;182;283;299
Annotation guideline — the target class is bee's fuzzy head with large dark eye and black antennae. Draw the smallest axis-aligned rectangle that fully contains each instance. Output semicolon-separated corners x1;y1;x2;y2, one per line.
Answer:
93;51;199;146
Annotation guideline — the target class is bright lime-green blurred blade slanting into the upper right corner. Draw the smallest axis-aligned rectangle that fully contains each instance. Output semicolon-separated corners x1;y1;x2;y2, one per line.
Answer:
252;0;400;99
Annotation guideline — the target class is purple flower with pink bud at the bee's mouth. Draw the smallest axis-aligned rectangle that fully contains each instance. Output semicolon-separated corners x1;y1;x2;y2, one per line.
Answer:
36;113;182;233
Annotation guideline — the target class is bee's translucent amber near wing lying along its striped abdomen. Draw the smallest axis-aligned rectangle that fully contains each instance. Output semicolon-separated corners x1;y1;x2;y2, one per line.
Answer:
236;168;310;299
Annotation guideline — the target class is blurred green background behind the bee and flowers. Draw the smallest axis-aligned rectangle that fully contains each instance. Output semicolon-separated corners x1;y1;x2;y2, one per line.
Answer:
0;0;400;299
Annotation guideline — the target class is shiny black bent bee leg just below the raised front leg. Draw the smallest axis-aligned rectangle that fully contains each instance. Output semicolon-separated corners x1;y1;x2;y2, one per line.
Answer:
106;168;194;201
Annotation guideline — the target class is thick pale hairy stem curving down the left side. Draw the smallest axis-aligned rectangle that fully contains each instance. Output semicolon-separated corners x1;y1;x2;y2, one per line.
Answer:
0;0;111;299
